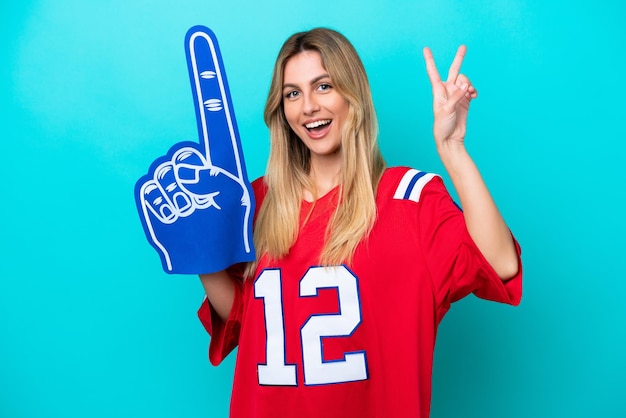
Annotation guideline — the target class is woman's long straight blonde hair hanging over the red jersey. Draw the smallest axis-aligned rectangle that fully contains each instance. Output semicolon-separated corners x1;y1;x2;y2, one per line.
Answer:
248;28;385;273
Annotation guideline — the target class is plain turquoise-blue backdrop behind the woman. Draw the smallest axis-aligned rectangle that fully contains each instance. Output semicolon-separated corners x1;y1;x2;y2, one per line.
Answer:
0;0;626;418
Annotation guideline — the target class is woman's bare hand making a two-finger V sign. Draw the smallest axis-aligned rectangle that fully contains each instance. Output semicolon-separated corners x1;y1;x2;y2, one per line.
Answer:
424;45;478;147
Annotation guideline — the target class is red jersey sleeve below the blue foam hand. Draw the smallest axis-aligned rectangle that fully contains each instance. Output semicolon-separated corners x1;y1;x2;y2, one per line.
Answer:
198;266;243;366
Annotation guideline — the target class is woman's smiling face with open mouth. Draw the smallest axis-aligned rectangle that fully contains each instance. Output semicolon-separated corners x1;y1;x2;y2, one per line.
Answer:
283;51;350;168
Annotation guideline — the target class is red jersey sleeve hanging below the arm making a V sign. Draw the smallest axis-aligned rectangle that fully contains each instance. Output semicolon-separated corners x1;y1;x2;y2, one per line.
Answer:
418;176;522;312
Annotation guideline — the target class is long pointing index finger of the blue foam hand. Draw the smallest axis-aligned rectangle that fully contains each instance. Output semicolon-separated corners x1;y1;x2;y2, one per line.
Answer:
185;26;245;179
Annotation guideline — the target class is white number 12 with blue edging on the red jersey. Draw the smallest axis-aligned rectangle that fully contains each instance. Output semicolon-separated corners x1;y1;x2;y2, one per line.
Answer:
254;266;367;386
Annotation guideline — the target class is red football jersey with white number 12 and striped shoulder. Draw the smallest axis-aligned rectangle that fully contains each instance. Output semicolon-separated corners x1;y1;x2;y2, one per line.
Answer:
198;167;522;418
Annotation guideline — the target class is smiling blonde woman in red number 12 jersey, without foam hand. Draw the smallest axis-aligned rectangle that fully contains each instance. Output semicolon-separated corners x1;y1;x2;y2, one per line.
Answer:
199;29;521;418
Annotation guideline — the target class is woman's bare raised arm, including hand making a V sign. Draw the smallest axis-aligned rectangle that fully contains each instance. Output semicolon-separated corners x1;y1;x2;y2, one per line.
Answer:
424;45;518;280
